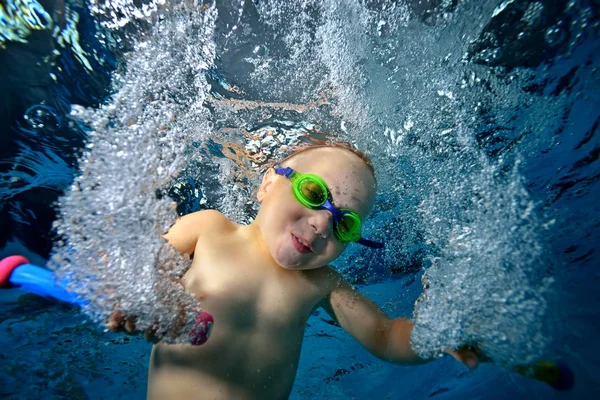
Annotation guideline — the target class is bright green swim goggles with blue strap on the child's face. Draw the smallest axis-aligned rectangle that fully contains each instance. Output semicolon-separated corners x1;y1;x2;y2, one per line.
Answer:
275;167;383;248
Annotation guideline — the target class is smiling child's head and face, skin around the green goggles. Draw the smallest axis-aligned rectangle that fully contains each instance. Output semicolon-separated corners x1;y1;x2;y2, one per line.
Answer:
257;148;375;270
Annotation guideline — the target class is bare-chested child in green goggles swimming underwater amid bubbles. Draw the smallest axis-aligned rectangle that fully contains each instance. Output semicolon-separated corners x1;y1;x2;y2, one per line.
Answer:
109;143;478;400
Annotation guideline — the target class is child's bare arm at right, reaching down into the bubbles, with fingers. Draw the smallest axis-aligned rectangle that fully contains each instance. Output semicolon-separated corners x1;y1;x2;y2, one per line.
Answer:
321;271;478;368
